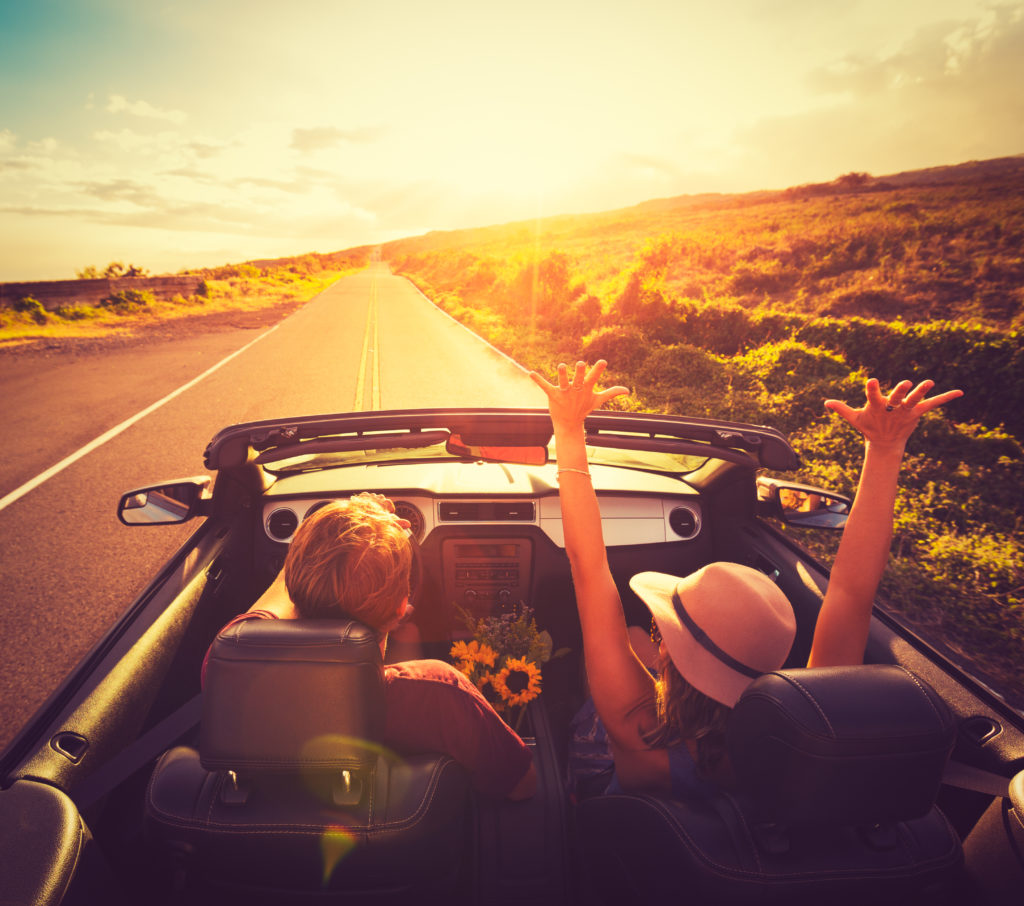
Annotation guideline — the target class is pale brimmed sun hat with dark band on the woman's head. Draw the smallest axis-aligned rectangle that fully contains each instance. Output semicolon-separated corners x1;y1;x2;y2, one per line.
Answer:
630;562;797;707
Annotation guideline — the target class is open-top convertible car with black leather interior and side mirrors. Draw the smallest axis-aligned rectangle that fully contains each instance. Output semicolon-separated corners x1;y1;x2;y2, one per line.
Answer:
0;409;1024;904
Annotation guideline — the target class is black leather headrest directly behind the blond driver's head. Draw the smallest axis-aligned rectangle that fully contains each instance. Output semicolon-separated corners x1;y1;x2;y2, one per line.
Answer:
200;619;384;773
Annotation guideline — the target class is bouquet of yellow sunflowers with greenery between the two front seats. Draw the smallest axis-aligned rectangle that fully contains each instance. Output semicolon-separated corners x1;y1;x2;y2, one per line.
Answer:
451;605;568;729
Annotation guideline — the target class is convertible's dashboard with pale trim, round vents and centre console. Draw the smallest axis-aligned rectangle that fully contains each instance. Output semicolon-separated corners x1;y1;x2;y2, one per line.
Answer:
251;464;710;623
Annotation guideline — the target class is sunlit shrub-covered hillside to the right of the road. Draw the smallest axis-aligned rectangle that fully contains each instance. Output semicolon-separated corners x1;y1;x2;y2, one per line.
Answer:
382;157;1024;706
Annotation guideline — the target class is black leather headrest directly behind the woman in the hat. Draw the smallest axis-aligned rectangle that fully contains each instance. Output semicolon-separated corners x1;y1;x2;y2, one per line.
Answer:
727;664;955;825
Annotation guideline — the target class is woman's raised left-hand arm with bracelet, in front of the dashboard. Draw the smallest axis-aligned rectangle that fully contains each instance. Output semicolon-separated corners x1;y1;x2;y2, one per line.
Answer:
530;360;656;782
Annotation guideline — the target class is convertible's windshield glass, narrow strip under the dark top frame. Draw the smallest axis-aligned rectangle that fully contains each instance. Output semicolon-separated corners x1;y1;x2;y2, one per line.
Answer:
265;442;710;475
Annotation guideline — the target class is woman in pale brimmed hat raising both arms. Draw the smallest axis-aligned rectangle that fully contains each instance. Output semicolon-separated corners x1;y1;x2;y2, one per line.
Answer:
530;360;962;795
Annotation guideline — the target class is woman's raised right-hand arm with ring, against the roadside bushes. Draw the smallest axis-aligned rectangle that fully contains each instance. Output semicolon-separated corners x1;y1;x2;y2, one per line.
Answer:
807;378;963;666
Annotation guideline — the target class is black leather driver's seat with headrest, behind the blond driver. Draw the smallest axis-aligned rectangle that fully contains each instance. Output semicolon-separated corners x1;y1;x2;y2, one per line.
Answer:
145;620;469;903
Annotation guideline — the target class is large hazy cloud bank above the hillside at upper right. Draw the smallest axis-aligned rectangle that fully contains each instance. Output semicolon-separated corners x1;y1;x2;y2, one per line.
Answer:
734;6;1024;187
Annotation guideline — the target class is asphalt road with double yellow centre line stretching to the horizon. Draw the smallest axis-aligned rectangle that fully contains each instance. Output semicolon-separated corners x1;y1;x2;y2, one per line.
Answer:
0;264;546;746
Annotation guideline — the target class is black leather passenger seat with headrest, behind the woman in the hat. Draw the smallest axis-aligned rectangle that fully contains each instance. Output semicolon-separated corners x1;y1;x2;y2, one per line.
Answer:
577;665;963;906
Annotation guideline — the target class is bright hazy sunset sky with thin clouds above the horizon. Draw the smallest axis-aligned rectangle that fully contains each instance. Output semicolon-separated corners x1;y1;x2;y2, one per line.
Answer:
0;0;1024;282
